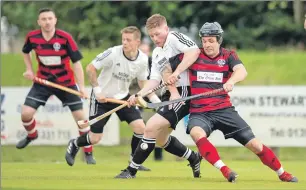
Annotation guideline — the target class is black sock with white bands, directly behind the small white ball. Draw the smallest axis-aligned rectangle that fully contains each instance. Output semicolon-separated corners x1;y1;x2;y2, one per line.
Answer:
127;138;156;175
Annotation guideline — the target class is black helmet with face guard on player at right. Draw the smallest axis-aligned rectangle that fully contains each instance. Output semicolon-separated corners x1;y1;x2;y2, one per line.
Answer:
199;22;223;44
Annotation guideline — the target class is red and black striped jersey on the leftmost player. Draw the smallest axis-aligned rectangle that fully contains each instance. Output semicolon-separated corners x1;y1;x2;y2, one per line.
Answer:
22;29;83;86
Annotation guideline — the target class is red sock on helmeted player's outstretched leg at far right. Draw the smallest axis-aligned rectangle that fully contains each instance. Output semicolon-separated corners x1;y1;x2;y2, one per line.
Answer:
257;145;281;171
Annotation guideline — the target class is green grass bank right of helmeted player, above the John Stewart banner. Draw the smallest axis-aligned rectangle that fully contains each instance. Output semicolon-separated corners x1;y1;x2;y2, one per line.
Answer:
238;50;306;85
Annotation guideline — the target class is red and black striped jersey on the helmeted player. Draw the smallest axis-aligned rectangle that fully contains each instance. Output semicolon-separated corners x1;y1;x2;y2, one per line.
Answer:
169;48;242;113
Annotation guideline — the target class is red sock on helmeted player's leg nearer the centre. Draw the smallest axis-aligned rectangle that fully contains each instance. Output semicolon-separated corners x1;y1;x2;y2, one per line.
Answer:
196;137;220;165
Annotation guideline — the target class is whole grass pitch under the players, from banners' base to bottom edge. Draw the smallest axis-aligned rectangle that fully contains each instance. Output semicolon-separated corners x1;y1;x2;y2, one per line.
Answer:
1;146;306;190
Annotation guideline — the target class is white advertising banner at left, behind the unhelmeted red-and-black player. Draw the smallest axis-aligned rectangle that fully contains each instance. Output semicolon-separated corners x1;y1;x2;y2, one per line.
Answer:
1;87;120;145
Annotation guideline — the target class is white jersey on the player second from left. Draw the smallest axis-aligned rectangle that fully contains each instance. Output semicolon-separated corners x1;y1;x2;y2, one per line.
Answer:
91;45;148;99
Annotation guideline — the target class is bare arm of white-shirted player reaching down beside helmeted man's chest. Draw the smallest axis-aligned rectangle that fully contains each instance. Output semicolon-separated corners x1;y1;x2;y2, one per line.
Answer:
167;48;200;84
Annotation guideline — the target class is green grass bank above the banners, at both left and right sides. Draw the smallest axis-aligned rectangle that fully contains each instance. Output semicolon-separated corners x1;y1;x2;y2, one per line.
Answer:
1;50;306;86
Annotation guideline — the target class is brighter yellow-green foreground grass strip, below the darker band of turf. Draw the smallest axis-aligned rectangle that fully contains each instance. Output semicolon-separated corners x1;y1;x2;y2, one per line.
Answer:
1;160;306;190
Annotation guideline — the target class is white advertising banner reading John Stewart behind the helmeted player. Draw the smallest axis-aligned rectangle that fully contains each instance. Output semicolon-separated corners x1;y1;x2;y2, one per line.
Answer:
173;86;306;147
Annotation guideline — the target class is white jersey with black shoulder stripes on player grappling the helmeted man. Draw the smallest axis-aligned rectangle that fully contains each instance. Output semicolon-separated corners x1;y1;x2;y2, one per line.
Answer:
150;31;198;86
